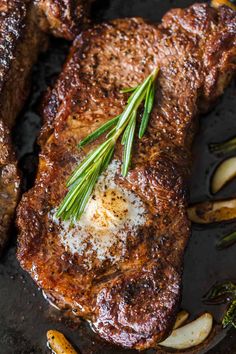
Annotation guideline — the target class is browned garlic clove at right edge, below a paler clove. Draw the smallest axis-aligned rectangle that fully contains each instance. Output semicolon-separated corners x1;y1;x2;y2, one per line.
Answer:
188;199;236;224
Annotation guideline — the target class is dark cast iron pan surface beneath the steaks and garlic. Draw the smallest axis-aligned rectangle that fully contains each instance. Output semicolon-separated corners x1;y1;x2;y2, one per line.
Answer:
0;0;236;354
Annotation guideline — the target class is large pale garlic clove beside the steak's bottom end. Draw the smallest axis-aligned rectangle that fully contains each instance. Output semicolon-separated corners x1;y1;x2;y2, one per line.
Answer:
158;313;213;349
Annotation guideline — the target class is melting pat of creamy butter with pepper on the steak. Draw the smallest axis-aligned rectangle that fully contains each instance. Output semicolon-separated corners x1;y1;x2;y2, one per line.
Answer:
53;161;146;266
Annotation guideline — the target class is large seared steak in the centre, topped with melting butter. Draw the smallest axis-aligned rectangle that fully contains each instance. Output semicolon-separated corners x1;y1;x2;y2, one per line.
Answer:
17;4;236;349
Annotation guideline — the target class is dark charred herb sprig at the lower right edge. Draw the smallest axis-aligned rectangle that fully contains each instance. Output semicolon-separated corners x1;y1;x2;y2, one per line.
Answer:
204;281;236;328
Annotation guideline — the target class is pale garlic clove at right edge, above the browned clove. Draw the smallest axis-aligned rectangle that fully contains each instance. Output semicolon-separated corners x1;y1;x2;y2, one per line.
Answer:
211;157;236;193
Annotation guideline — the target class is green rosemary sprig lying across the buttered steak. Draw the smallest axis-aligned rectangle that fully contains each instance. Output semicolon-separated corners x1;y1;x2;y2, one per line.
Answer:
56;68;159;222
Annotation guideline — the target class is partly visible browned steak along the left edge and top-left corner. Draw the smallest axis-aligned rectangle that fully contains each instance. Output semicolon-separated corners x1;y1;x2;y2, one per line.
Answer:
0;0;91;251
